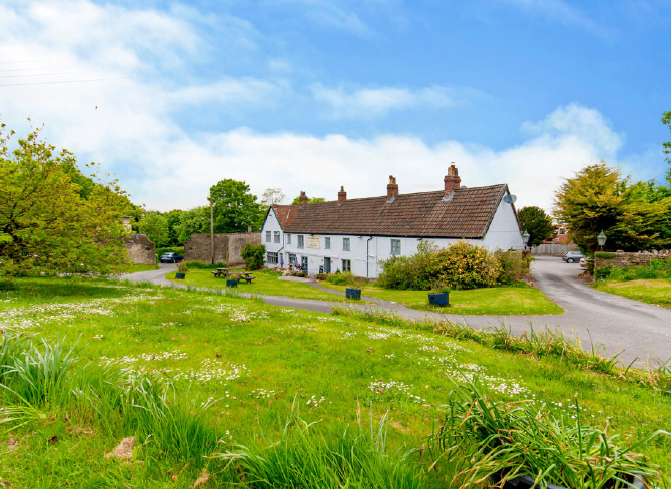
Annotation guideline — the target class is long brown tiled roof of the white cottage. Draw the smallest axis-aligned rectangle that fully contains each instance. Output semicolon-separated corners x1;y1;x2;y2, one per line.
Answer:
274;184;508;238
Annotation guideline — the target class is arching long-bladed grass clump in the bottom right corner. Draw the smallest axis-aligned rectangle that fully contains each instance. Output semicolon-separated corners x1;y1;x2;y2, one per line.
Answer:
428;380;671;489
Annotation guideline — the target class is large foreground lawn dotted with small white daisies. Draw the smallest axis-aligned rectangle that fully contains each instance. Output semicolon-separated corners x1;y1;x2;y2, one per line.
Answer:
0;276;671;489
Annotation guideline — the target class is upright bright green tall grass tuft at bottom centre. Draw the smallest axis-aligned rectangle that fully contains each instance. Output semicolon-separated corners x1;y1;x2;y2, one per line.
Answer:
218;399;427;489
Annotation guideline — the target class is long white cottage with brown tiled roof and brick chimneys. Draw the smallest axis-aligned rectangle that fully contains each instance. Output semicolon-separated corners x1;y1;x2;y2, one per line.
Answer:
261;164;524;277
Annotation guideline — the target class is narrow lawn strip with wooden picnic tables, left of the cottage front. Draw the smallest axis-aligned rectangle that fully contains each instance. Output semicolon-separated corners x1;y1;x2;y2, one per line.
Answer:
166;268;347;302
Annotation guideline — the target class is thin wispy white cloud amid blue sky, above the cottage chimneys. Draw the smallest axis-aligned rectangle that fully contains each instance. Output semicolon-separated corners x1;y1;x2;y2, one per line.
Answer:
310;83;482;119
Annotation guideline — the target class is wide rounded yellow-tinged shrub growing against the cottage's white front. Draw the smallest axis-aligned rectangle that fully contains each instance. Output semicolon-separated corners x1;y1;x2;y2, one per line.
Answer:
379;241;505;290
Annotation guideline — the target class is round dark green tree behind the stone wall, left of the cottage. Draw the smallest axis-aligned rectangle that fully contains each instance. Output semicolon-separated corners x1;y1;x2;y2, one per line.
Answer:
210;178;265;233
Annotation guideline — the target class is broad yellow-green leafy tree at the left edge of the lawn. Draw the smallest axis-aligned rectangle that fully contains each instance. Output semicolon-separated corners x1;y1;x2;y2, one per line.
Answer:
0;120;129;276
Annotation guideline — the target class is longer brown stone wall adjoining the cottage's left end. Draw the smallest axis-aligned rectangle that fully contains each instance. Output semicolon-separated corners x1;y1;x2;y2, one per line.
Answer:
184;233;261;265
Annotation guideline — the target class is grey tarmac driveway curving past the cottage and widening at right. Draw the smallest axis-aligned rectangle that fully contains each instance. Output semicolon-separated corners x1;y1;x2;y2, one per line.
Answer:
121;256;671;367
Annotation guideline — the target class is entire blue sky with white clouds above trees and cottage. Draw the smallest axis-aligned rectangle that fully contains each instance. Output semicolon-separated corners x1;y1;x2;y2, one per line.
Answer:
0;0;671;211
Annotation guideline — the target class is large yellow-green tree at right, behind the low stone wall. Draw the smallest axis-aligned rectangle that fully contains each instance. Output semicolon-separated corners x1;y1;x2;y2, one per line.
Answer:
555;161;671;252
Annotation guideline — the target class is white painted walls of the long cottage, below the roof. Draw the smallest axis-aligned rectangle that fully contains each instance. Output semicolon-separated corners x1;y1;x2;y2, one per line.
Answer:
261;195;524;277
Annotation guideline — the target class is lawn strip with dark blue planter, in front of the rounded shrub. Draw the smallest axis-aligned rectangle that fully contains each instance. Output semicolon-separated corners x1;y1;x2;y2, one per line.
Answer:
320;282;564;316
